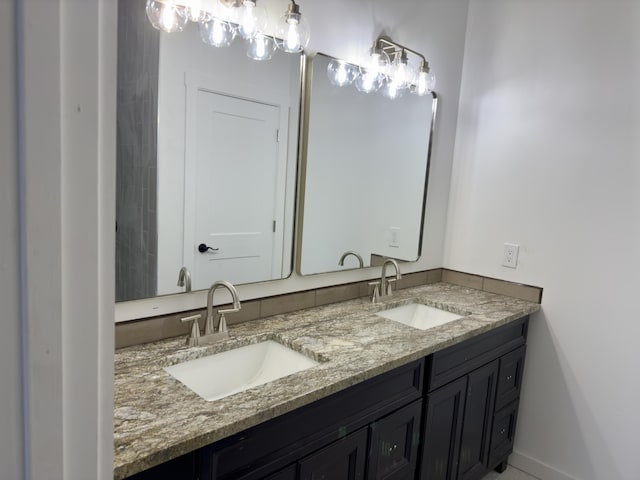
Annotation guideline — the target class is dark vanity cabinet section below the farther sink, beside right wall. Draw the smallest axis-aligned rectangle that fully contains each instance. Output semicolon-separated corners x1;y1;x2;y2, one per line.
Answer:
419;318;528;480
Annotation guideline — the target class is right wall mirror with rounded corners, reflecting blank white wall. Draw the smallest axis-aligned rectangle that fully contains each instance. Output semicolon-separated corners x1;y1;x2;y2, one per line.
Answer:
297;54;437;275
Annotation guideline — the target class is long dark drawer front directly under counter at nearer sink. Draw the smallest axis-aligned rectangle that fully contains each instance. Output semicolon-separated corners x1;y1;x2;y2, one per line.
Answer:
202;360;424;480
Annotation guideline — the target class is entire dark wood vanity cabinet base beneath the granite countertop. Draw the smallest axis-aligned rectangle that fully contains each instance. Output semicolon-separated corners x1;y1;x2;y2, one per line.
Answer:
122;317;528;480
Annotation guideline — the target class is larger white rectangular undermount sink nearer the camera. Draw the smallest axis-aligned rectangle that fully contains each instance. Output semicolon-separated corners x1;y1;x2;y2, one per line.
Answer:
165;340;318;401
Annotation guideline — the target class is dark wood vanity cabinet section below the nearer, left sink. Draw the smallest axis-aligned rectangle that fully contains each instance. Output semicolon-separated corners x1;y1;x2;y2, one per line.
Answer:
198;359;425;480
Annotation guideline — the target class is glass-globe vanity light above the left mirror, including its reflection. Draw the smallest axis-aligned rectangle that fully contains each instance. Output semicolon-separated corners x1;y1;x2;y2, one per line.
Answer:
146;0;309;60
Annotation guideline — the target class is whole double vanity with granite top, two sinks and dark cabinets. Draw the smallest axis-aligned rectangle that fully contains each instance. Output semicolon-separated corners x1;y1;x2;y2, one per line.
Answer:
114;283;539;480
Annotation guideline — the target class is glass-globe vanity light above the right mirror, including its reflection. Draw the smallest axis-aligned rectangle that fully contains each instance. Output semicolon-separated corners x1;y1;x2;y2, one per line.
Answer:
327;37;435;99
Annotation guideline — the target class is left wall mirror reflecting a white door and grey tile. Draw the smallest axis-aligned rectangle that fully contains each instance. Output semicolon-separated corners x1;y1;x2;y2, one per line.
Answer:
116;0;304;301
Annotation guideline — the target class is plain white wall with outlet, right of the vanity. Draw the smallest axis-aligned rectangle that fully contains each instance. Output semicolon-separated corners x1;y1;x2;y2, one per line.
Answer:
444;0;640;480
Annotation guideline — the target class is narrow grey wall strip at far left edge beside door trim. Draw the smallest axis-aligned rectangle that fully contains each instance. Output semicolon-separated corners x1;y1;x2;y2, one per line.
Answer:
0;2;24;479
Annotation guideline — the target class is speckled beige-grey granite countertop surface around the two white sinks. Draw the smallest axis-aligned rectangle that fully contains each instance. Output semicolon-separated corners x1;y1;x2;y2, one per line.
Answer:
114;283;540;480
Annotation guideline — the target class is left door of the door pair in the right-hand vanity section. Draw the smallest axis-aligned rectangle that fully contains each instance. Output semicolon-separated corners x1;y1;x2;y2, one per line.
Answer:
420;377;467;480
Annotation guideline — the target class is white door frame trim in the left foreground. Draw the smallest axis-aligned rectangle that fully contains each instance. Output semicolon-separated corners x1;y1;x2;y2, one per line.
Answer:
6;0;116;480
